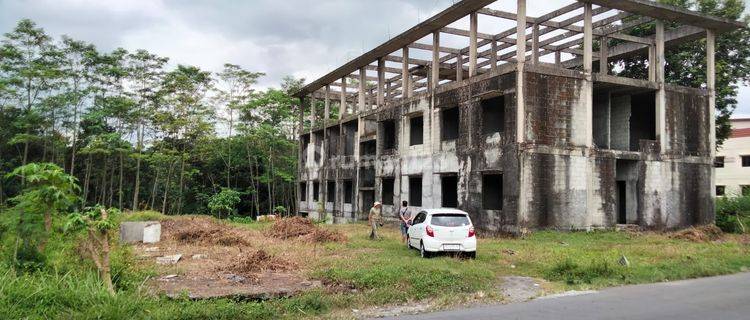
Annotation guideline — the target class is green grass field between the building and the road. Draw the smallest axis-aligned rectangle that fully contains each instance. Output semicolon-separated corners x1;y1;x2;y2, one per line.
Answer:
0;214;750;319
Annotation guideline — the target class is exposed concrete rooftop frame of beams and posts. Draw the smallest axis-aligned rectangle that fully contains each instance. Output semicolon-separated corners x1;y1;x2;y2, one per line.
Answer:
297;0;745;104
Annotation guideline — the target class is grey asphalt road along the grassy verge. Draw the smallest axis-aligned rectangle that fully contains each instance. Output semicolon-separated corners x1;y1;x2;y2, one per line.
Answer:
388;273;750;320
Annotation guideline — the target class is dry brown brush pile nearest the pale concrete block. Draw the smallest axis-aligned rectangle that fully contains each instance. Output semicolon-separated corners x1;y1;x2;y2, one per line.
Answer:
161;217;250;246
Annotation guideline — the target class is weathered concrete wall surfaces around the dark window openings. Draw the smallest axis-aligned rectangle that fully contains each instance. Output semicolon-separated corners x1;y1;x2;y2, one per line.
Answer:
300;69;713;231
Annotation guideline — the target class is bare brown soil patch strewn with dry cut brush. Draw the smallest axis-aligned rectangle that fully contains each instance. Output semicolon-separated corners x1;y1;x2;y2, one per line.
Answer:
141;217;321;300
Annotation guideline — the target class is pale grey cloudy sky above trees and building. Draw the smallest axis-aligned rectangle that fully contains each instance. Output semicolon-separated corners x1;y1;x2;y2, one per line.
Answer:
0;0;750;117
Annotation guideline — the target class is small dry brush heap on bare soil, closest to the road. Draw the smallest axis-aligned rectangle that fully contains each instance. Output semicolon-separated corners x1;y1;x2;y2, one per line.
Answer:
217;249;298;277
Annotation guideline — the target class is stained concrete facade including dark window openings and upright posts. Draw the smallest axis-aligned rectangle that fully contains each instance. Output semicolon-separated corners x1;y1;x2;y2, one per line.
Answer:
298;0;748;232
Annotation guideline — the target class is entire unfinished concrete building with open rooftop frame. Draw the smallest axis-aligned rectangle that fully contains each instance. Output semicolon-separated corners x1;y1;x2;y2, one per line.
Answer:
298;0;743;232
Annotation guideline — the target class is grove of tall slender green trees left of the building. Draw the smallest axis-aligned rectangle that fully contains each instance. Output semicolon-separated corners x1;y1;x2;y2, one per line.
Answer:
0;20;304;215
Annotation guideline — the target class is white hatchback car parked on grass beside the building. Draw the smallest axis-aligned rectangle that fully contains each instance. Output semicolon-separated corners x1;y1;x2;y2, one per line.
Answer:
406;208;477;259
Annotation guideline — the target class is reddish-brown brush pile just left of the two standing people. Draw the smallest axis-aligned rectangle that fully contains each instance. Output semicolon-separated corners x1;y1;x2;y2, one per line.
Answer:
268;217;347;242
